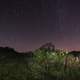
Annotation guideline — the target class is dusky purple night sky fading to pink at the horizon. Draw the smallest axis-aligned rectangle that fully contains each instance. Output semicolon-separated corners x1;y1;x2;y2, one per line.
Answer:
0;0;80;51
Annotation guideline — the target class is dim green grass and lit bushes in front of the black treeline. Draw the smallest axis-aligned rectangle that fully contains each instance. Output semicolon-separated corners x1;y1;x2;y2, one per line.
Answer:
0;49;80;80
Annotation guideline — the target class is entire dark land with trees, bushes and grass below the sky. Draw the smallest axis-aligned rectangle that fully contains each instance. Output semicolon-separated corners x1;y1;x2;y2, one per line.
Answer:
0;43;80;80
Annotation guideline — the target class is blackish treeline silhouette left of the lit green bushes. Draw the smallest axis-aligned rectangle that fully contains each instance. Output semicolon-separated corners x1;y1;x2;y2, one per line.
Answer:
0;47;33;62
